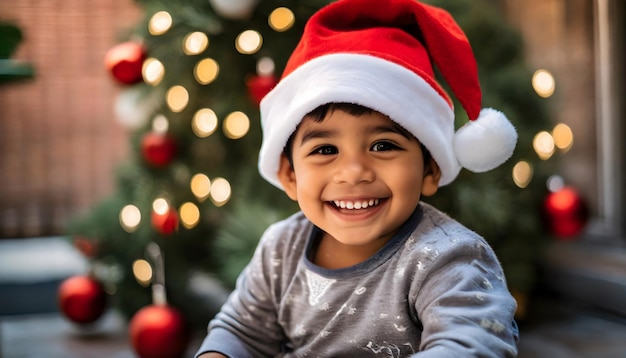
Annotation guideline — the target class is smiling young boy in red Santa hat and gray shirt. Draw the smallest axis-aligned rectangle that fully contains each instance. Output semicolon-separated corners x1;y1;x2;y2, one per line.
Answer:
197;0;518;358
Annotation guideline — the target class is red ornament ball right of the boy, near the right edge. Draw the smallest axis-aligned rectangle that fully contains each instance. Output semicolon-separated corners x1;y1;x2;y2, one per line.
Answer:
544;187;589;239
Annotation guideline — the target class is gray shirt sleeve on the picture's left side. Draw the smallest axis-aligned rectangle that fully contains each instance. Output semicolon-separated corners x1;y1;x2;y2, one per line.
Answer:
196;225;284;358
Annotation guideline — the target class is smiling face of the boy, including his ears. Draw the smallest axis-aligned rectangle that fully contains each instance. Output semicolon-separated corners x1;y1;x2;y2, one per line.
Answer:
278;110;440;247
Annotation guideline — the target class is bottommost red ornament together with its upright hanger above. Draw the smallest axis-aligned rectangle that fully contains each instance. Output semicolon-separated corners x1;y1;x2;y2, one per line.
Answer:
128;243;189;358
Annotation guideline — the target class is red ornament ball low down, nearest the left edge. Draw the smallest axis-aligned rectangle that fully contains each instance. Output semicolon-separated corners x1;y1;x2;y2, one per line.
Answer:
58;275;106;324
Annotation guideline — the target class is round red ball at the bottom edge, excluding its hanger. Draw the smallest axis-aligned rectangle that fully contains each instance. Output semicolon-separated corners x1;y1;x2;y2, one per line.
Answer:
129;305;189;358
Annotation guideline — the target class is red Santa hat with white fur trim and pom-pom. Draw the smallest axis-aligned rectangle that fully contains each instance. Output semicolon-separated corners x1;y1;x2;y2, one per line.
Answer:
259;0;517;188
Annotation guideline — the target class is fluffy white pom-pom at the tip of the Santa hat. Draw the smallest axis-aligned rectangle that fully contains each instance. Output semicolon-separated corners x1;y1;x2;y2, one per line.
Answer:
452;108;517;173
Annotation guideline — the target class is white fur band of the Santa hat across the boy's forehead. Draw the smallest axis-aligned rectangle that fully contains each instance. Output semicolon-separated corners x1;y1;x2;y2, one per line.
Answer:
258;54;461;189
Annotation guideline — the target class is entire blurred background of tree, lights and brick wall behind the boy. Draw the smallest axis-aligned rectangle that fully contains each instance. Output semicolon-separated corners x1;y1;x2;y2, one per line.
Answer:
0;0;626;357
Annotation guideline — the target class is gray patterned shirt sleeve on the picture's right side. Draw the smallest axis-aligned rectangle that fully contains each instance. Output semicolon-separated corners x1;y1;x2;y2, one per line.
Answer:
412;230;518;358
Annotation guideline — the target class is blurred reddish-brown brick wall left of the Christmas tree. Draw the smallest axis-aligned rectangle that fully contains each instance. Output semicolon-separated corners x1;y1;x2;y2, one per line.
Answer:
0;0;141;237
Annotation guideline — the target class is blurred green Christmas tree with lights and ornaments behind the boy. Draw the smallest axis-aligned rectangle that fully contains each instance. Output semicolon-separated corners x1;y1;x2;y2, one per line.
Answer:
68;0;552;332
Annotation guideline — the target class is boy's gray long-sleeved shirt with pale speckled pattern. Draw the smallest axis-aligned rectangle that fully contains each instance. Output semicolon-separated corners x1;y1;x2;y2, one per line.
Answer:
197;203;518;358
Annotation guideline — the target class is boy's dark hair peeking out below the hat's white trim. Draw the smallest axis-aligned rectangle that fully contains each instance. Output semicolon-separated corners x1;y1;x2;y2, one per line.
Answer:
283;102;432;171
